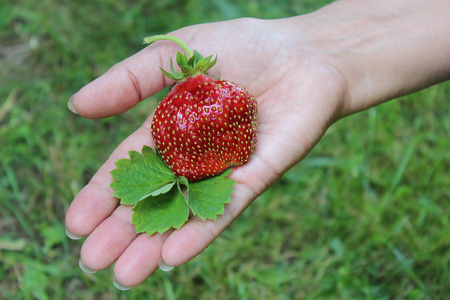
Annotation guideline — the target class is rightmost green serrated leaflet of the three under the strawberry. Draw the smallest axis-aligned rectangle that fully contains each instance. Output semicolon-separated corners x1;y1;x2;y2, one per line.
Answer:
188;170;236;220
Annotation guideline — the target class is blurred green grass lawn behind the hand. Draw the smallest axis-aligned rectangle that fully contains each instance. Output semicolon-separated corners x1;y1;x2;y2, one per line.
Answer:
0;0;450;299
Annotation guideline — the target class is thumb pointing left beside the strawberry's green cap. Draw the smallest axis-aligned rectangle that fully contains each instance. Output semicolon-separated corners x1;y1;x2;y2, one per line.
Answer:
69;41;183;119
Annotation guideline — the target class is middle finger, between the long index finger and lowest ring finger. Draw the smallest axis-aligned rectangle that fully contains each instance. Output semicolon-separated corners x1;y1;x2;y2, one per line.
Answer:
81;205;137;271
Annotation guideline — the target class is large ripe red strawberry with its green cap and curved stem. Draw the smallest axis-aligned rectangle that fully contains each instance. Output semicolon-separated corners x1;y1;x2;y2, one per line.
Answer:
145;35;257;182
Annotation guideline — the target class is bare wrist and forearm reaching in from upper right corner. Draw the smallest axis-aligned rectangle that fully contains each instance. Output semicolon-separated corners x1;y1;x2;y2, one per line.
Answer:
286;0;450;116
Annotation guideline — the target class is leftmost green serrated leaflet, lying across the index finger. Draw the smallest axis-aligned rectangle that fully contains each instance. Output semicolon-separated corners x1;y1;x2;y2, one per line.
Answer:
111;146;177;205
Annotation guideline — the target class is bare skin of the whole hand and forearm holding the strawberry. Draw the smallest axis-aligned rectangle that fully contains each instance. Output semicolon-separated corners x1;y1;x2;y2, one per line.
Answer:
66;0;450;287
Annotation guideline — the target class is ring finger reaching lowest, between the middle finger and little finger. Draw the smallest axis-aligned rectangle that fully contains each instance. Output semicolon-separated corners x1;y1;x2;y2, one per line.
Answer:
114;231;170;287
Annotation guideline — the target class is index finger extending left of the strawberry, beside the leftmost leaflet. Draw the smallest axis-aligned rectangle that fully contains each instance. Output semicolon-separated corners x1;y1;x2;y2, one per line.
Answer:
66;117;153;236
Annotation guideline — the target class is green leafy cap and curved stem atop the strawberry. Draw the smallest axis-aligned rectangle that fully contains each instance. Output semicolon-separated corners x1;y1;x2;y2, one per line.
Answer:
144;35;217;81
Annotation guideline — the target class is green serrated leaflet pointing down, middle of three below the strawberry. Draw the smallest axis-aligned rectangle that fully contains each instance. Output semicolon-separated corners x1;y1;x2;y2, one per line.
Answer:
132;186;189;235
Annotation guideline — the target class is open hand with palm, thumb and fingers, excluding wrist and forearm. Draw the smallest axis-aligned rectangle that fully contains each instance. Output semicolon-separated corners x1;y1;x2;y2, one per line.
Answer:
66;19;344;286
